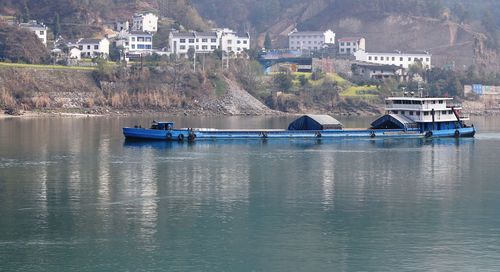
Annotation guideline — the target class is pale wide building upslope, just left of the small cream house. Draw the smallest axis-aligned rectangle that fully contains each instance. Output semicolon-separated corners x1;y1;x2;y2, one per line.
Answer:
288;29;335;51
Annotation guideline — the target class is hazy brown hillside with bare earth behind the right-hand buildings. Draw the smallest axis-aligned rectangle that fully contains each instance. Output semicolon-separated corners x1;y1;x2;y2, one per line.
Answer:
193;0;500;71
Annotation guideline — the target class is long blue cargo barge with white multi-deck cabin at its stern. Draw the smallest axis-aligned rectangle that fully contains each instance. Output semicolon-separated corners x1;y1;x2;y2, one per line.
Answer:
123;97;476;142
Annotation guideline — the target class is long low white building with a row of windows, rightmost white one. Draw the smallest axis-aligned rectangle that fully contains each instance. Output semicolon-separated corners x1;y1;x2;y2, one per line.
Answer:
354;50;432;69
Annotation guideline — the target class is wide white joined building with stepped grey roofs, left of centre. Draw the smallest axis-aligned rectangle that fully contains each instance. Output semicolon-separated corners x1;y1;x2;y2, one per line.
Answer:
169;29;250;56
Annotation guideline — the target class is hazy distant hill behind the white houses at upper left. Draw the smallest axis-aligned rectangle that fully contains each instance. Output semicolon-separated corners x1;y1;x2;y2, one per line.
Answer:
0;0;207;37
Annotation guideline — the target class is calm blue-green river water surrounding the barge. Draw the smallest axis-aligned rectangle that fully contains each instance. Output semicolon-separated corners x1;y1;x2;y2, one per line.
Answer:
0;117;500;271
